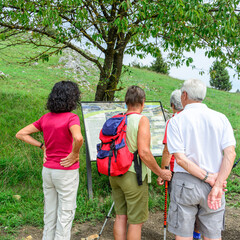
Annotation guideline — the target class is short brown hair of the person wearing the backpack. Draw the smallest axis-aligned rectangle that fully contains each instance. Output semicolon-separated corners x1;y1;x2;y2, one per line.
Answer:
125;86;145;106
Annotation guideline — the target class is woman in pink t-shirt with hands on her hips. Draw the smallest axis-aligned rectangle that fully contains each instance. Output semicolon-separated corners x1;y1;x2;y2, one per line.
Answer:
16;81;83;240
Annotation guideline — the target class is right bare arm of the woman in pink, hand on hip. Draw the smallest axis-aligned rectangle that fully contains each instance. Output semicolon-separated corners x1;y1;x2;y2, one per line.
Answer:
60;125;83;167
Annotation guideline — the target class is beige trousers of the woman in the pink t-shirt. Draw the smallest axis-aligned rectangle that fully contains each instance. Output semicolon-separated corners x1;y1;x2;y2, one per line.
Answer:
42;167;79;240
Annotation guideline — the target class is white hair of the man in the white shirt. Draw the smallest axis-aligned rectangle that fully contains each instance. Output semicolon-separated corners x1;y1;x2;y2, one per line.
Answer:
181;79;207;102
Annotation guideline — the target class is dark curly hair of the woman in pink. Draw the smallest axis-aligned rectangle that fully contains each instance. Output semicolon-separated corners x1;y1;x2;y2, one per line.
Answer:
47;81;80;113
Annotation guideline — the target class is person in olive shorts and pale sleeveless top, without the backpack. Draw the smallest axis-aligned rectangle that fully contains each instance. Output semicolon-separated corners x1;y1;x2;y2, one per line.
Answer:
109;86;172;240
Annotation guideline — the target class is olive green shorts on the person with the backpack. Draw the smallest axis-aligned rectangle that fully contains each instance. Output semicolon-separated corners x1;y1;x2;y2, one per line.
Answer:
109;172;148;224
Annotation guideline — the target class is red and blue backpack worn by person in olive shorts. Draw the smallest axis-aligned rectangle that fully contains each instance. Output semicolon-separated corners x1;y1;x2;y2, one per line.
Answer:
97;112;142;185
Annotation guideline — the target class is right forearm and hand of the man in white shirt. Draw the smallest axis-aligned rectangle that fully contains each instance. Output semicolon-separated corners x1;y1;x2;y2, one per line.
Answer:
208;146;236;210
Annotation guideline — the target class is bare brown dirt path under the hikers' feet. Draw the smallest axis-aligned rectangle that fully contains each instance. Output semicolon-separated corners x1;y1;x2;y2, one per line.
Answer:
16;207;240;240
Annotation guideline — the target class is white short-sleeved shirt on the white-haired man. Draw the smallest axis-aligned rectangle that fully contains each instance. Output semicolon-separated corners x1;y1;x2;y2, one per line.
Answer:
167;103;236;173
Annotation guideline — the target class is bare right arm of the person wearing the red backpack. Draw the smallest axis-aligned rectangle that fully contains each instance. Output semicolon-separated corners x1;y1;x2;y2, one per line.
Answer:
137;116;172;181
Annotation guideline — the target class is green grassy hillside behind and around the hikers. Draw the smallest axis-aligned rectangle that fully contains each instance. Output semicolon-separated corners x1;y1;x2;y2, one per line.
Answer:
0;42;240;239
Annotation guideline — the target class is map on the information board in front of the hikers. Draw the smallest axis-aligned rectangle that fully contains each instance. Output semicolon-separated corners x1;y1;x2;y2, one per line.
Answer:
81;102;165;161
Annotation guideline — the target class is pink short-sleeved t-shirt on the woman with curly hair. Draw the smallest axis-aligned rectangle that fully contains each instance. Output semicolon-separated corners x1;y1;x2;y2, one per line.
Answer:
33;112;80;170
